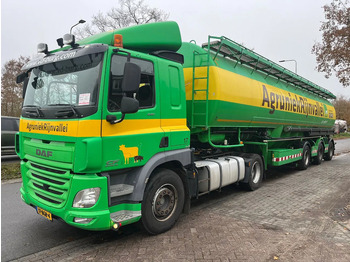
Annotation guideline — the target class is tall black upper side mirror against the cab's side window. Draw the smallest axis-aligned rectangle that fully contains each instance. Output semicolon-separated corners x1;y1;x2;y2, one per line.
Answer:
122;62;141;94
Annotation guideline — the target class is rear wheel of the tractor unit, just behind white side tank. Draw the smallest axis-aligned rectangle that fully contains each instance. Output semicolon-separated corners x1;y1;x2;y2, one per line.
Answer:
244;155;264;191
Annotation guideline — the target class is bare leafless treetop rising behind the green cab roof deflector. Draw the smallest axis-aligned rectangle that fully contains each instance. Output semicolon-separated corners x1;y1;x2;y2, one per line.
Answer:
75;0;169;39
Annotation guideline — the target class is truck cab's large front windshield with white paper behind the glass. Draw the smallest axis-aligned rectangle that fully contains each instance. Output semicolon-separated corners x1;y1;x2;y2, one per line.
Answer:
23;53;103;109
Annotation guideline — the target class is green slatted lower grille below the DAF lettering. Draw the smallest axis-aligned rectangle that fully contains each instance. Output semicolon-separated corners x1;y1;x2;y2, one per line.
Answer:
26;161;72;208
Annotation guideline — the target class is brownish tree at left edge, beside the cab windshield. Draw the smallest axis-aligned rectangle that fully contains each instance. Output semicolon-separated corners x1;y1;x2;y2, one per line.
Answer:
1;56;29;116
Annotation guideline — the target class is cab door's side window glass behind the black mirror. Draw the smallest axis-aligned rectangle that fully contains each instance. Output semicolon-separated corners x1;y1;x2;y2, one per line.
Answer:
108;55;155;112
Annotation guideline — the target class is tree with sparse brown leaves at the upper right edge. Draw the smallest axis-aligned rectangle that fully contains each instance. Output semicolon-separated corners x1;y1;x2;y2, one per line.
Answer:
312;0;350;86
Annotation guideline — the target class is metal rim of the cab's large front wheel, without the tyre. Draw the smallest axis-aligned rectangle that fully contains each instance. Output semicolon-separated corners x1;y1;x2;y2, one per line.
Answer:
152;184;178;221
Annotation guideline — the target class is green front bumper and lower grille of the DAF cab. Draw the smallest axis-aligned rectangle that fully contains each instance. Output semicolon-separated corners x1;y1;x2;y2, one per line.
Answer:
20;161;141;231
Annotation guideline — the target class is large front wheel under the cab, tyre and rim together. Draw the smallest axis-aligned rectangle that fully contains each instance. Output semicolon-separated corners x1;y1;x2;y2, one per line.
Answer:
141;169;185;235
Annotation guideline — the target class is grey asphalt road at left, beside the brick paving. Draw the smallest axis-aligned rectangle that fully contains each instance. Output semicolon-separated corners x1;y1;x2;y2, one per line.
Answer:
1;183;95;261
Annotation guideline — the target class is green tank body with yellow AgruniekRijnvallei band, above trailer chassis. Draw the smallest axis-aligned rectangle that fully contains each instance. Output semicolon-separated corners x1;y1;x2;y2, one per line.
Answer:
178;36;335;143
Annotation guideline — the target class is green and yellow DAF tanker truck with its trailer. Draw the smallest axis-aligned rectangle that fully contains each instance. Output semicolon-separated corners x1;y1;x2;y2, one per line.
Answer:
16;21;336;234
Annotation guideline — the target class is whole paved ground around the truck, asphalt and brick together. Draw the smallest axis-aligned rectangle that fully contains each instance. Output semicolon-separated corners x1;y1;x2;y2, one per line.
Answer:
1;139;350;261
